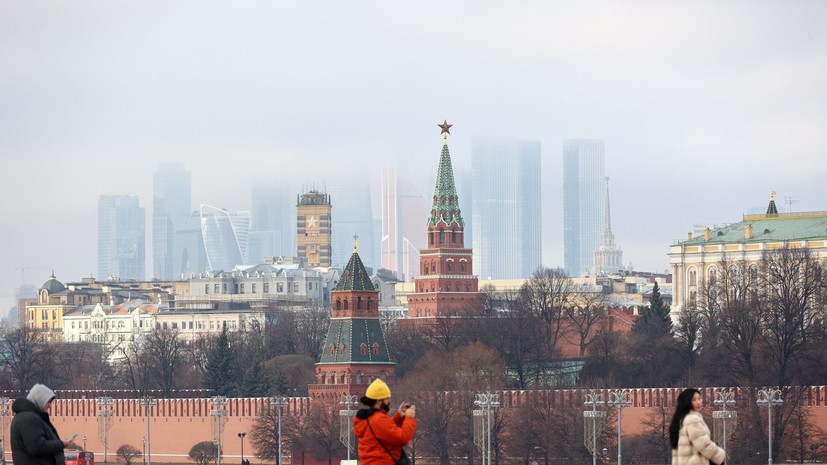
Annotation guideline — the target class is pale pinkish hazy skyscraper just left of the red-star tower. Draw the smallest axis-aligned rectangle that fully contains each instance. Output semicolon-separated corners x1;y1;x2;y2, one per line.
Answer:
381;169;428;281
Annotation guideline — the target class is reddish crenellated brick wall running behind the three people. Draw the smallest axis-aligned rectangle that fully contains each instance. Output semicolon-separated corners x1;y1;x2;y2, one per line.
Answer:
3;386;827;464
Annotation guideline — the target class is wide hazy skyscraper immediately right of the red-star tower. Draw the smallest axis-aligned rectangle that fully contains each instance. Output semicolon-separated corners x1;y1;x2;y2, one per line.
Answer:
471;137;543;279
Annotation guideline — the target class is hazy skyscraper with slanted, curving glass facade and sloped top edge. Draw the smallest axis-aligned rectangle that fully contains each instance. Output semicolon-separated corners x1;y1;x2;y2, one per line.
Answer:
200;205;250;273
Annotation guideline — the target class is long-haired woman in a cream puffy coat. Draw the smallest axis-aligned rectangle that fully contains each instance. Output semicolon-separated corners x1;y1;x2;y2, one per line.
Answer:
669;389;726;465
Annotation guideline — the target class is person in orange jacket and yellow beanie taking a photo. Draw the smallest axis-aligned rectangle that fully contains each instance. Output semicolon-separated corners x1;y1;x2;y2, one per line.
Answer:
353;378;416;465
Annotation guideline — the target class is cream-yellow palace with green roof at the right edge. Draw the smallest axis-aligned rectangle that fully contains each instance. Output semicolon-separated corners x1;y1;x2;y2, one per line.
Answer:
669;193;827;312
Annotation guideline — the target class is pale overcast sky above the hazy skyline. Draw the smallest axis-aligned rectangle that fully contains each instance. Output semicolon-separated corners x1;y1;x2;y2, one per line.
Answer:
0;0;827;314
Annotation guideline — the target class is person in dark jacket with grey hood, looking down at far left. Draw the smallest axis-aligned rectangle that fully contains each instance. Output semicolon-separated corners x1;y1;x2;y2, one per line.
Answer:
10;384;69;465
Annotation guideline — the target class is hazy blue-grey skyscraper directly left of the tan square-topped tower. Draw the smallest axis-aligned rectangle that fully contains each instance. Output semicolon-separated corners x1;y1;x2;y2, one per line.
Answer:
249;185;296;264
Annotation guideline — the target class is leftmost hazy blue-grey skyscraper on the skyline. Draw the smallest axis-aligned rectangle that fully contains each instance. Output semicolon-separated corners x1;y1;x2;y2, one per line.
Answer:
98;195;146;281
